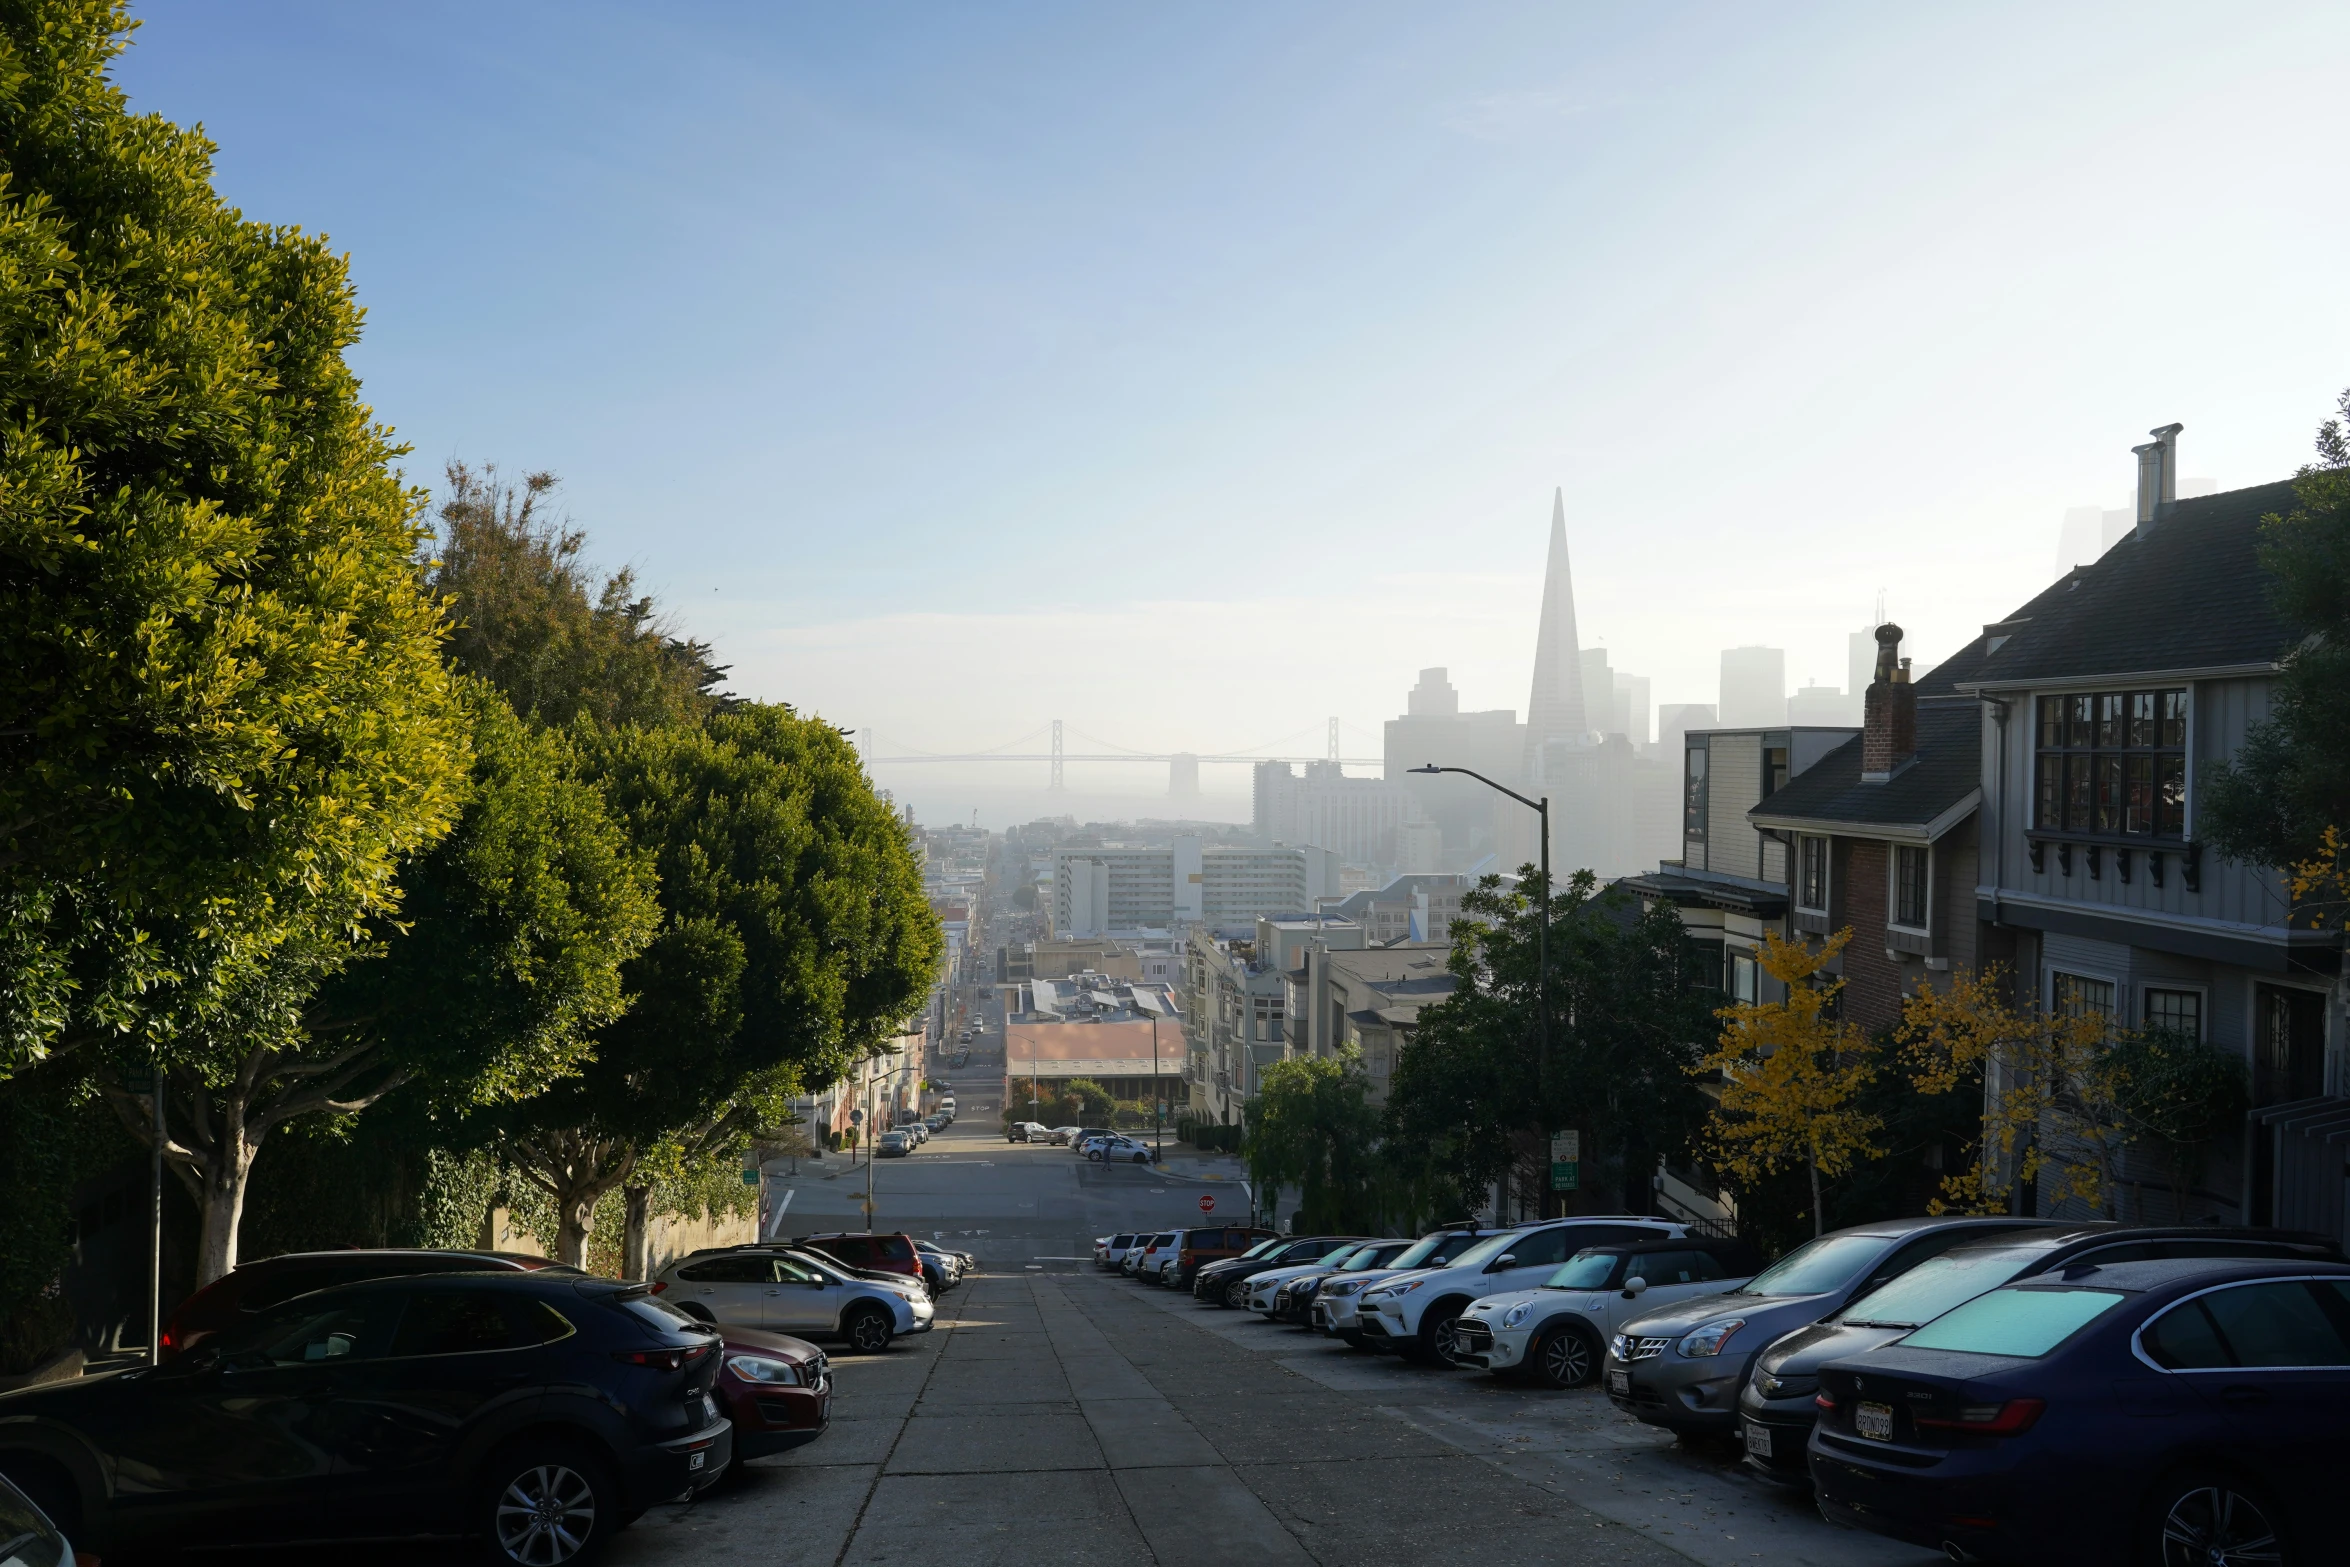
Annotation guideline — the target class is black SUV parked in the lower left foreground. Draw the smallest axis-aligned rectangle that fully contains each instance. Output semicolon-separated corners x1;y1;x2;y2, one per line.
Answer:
0;1273;733;1567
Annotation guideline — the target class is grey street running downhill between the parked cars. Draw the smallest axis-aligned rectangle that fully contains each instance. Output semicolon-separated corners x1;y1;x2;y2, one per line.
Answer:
611;1122;1939;1567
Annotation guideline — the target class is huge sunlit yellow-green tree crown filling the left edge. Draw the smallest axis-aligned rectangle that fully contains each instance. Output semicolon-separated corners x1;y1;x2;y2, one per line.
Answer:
0;0;465;1069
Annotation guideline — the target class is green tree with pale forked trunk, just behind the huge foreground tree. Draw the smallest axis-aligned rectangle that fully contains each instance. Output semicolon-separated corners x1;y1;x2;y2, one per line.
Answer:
103;681;656;1283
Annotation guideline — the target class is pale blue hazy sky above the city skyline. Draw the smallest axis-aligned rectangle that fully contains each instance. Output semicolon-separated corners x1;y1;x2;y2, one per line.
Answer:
120;0;2350;815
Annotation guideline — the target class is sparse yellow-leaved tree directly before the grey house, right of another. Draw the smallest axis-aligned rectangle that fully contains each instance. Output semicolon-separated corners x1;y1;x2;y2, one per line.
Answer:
1899;966;2131;1212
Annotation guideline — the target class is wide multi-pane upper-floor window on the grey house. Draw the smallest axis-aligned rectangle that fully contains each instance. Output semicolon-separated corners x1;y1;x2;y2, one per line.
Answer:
2035;691;2188;839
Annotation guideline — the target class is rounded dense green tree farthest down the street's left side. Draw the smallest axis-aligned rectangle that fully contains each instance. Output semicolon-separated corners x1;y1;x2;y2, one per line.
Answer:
496;702;945;1269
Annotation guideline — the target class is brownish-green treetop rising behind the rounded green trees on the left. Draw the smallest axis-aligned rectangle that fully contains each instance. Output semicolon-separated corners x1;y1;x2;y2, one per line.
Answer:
428;463;729;728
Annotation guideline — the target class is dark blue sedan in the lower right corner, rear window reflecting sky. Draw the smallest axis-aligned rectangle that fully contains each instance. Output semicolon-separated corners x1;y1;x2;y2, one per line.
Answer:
1810;1257;2350;1567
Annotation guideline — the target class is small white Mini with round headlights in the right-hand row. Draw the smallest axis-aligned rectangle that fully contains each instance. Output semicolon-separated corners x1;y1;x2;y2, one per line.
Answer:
1452;1236;1758;1388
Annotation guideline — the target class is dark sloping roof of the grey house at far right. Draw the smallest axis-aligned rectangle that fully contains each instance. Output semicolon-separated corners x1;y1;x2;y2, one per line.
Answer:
1955;479;2296;693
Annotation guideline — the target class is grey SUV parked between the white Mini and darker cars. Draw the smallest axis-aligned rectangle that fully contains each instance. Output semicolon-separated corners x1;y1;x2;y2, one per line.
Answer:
1603;1217;2056;1435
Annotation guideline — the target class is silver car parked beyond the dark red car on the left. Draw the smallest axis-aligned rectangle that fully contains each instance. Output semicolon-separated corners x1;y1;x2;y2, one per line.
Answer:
651;1247;933;1356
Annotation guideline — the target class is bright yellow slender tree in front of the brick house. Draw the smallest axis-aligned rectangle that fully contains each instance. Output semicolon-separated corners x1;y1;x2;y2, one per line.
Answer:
1694;930;1882;1236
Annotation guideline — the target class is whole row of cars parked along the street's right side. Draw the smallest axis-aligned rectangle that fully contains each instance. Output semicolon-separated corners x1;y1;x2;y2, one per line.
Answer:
1128;1215;2350;1567
